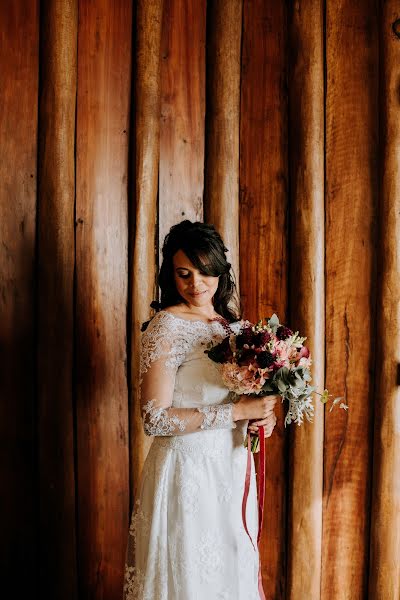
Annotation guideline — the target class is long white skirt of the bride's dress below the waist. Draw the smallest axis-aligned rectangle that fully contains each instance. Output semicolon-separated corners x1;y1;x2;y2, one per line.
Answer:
123;421;259;600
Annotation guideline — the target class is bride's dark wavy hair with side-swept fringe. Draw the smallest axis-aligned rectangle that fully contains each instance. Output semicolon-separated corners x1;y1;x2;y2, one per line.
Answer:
142;219;242;331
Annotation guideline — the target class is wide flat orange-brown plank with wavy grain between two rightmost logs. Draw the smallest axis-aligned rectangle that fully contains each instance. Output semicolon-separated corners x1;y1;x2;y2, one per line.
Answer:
321;0;378;600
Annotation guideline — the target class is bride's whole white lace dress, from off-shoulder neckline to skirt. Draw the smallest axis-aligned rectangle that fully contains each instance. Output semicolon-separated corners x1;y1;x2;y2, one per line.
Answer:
123;311;259;600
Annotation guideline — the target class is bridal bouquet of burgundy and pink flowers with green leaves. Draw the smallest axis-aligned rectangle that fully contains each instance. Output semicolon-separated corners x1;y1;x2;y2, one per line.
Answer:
205;314;348;452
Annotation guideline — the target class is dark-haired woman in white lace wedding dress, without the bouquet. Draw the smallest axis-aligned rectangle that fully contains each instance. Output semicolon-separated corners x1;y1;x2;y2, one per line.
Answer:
124;220;278;600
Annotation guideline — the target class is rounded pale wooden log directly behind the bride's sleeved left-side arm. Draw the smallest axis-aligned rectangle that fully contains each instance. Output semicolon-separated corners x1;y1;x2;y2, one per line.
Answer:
130;0;163;500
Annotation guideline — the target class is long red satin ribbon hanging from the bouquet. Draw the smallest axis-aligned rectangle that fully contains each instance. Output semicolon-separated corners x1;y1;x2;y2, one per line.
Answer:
242;427;266;600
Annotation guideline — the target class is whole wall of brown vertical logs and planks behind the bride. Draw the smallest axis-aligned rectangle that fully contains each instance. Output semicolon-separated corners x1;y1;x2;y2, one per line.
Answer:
0;0;400;600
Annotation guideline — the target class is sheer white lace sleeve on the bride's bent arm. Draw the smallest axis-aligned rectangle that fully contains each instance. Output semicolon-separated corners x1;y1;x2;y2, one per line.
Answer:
140;312;236;435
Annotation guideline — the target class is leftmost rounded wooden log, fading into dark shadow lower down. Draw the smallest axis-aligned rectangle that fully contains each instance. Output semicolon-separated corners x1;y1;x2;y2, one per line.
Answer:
37;0;78;600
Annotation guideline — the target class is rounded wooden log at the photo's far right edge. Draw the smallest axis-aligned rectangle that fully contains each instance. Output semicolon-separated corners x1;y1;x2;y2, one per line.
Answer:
368;1;400;600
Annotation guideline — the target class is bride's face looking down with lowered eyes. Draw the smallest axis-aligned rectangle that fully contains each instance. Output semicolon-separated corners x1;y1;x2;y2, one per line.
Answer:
172;250;219;306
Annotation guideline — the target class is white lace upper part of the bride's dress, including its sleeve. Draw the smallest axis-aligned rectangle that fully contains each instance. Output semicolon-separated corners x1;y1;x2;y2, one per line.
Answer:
140;310;240;436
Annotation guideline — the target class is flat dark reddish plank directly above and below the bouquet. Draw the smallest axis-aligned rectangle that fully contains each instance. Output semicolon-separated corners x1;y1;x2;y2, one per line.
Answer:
239;0;288;599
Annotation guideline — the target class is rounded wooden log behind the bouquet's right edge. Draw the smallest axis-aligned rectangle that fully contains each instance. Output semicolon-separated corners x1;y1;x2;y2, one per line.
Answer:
287;0;325;600
